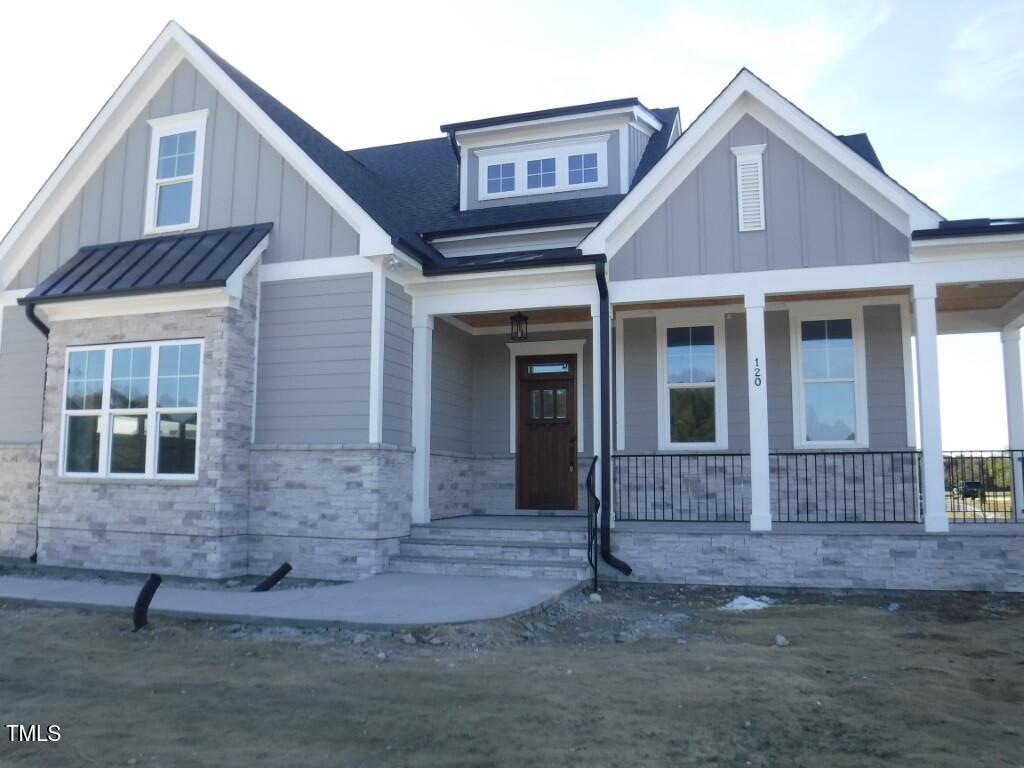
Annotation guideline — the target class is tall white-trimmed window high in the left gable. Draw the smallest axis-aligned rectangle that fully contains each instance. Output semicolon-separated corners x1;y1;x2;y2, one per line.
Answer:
144;110;208;233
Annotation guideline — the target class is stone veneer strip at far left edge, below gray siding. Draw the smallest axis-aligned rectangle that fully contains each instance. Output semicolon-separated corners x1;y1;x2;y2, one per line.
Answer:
0;443;39;557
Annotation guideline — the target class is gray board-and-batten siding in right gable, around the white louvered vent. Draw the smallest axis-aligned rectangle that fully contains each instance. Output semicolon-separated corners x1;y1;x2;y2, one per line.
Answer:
609;116;910;280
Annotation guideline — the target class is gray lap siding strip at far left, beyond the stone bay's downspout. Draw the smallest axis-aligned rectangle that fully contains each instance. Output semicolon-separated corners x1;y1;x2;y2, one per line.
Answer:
0;306;46;444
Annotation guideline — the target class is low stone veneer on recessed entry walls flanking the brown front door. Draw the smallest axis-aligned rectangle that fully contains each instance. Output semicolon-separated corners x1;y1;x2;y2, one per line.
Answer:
430;451;590;520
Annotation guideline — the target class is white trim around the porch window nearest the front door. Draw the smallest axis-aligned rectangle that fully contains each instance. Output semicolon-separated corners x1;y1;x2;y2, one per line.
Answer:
656;309;729;451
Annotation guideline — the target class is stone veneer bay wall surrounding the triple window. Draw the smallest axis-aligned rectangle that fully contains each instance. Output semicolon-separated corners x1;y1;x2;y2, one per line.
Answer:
39;268;258;578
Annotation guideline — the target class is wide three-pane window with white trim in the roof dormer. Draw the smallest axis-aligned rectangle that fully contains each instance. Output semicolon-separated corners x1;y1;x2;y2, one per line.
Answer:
474;134;610;200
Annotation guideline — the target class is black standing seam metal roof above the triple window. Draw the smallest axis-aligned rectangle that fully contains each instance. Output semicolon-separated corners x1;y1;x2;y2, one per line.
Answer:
19;223;273;304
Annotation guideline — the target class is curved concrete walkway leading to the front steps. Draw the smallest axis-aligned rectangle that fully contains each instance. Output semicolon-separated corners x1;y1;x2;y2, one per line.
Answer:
0;573;577;626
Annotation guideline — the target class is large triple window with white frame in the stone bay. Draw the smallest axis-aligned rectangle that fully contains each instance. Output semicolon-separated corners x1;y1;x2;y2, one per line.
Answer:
61;341;203;478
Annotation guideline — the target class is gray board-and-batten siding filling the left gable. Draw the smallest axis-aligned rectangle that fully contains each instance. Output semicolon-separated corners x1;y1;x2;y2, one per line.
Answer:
10;62;358;288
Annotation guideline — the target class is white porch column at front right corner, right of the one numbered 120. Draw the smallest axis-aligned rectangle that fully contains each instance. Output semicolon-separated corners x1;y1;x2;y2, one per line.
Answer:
913;283;949;534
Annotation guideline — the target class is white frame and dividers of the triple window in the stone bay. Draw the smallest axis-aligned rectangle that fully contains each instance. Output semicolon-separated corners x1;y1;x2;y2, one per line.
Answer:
58;339;205;482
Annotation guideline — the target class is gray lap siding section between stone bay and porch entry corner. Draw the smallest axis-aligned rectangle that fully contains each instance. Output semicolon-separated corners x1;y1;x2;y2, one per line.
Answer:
256;275;371;444
